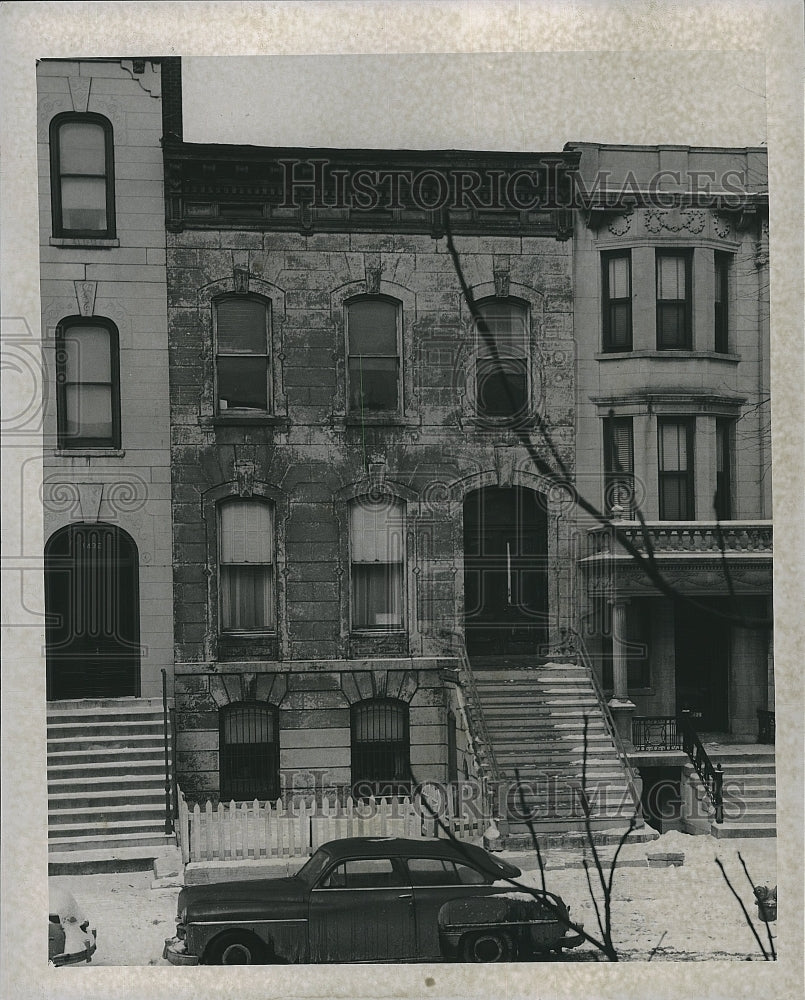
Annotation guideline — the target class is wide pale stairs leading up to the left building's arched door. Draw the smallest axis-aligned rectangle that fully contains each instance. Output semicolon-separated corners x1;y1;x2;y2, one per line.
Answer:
47;698;176;872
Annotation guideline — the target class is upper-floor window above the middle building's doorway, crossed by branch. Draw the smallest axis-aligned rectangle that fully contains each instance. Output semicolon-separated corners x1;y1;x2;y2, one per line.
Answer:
475;299;530;417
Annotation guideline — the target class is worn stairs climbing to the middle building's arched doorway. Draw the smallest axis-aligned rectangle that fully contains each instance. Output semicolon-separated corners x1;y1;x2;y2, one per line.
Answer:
471;657;656;846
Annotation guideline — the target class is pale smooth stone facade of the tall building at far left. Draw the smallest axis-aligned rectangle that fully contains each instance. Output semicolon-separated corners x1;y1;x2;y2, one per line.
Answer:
37;59;173;701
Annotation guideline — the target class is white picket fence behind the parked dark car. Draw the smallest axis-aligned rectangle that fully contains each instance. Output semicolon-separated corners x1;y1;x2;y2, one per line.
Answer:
177;790;488;863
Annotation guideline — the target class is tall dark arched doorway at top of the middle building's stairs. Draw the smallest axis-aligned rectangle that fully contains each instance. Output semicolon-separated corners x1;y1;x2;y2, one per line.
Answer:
464;486;548;656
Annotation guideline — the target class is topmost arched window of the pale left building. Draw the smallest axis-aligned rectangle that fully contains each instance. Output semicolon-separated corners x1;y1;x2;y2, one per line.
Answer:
50;112;115;239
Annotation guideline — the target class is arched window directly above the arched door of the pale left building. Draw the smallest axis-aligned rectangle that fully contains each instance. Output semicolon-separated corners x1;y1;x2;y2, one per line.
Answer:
56;316;120;448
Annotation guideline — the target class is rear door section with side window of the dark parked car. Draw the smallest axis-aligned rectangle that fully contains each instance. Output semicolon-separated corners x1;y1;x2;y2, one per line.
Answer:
407;858;493;960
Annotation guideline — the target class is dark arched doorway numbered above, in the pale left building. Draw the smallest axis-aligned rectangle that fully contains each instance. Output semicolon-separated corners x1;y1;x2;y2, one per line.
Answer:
45;524;140;701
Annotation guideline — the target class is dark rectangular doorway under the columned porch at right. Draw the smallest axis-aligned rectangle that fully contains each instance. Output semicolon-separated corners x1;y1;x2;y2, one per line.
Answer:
674;598;730;733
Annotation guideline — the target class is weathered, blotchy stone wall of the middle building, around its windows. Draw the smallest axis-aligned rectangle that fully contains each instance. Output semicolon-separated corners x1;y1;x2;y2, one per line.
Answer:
168;230;575;796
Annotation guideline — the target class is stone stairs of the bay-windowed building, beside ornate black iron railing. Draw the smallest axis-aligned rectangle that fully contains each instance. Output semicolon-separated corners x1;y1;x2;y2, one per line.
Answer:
705;744;777;838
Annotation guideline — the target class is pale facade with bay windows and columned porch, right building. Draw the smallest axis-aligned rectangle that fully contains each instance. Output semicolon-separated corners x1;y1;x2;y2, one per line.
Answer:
570;143;774;741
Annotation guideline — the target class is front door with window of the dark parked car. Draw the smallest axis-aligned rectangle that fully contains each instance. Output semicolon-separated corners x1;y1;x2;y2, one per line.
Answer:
308;858;417;962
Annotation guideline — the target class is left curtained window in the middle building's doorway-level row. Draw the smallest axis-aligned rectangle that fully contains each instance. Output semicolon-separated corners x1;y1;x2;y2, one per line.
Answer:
218;499;275;632
